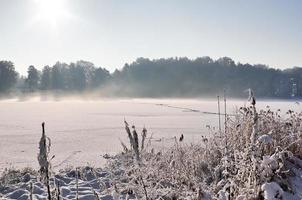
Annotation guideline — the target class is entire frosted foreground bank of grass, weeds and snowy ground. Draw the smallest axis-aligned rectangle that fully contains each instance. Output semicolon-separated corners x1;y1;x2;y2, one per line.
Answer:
0;101;302;200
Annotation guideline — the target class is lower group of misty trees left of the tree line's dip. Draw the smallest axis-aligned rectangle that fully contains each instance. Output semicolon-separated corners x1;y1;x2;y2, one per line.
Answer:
0;61;111;93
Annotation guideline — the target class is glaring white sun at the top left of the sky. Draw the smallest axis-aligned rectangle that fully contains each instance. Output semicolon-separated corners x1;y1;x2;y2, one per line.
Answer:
35;0;69;26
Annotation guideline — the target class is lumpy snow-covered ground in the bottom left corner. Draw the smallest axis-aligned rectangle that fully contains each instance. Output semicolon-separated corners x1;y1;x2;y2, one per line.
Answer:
0;167;131;200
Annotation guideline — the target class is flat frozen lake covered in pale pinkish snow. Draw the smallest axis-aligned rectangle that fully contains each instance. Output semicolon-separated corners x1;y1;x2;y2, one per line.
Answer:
0;99;302;171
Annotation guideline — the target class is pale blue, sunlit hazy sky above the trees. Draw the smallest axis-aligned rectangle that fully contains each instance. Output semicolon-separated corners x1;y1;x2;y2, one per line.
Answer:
0;0;302;74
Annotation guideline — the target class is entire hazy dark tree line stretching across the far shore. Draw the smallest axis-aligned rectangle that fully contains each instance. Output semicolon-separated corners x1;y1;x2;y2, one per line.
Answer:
0;57;302;98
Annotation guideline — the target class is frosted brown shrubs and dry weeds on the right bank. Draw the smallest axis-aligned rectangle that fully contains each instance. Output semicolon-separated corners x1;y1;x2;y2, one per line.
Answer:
111;98;302;200
